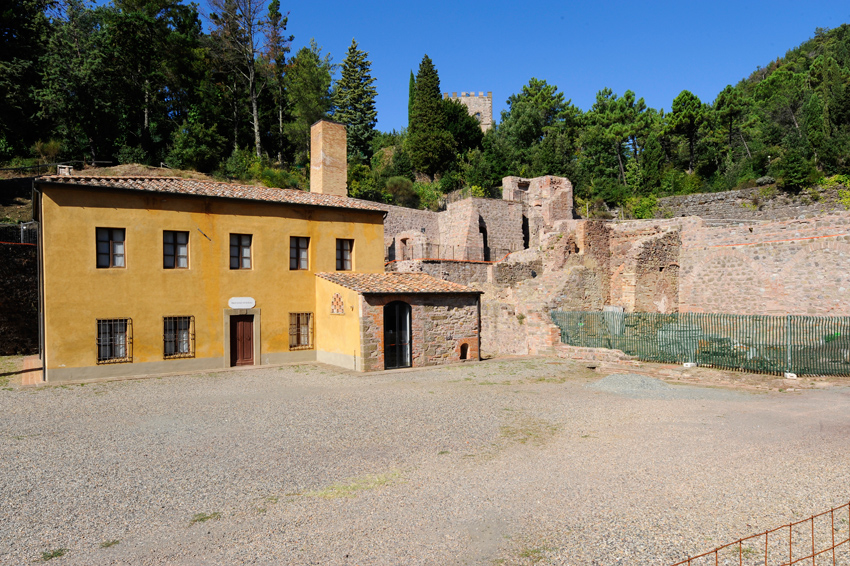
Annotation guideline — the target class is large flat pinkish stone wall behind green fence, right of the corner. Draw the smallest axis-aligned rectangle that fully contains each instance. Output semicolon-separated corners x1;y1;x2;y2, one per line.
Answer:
679;212;850;316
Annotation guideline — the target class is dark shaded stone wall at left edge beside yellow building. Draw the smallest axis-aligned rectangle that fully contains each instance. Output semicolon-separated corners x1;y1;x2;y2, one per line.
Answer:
0;244;38;356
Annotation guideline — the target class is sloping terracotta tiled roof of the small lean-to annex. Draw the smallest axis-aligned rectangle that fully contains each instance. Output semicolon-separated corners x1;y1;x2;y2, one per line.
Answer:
316;271;482;295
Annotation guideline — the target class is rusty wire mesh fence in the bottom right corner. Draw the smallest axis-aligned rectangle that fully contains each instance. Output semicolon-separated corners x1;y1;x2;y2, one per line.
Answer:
672;503;850;566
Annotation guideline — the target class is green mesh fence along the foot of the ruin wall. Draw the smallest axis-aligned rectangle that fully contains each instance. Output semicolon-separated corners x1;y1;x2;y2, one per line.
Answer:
551;311;850;375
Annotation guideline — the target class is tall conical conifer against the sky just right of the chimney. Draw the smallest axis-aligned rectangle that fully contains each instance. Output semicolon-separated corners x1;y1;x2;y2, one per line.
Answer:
333;39;378;161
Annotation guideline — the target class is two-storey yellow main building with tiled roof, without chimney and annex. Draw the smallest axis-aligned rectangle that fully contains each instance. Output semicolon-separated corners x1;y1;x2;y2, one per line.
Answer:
36;177;384;381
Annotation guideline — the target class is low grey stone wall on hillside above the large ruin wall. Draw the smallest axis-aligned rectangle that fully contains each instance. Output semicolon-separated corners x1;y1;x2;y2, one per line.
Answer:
655;188;845;220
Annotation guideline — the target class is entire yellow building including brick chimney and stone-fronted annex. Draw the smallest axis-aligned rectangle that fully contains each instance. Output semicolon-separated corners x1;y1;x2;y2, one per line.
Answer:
33;121;480;382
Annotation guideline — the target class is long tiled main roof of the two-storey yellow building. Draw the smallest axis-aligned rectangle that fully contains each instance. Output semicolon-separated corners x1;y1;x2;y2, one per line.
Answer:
36;175;383;212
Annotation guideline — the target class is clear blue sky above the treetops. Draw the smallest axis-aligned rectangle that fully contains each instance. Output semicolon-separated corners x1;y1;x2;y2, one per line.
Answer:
227;0;850;131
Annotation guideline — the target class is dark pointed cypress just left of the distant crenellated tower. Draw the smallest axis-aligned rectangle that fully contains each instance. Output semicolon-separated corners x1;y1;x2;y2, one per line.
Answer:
408;55;455;175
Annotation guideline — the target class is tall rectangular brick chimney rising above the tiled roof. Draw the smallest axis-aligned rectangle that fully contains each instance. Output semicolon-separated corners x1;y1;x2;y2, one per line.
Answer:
310;119;348;197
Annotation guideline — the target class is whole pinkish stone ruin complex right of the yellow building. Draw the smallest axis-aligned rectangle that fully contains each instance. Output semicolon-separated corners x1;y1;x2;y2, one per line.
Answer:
378;176;850;362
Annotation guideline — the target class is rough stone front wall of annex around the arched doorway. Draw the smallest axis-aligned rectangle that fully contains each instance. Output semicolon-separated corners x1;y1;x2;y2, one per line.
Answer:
360;294;479;371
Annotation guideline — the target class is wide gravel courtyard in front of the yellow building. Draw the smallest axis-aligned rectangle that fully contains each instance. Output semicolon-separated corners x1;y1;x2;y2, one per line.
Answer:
0;358;850;565
